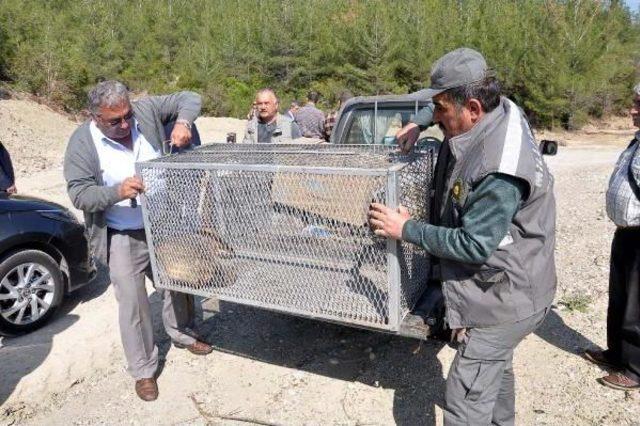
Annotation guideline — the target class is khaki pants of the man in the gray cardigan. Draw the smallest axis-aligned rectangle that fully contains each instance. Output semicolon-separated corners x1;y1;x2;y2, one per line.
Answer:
108;229;196;380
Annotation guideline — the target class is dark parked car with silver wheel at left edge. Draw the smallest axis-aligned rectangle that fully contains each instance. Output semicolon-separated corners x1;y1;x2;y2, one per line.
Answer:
0;194;96;335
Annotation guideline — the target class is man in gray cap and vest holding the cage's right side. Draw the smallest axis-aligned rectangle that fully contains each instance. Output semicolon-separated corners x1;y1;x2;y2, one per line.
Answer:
370;48;556;425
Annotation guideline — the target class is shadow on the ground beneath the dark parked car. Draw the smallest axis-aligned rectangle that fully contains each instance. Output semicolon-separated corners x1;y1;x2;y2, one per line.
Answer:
0;266;109;405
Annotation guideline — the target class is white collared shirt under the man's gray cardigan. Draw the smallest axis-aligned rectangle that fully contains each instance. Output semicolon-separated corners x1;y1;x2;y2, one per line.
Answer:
89;119;160;231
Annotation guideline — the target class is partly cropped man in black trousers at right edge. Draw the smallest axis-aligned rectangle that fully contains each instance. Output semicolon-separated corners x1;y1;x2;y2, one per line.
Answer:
584;83;640;390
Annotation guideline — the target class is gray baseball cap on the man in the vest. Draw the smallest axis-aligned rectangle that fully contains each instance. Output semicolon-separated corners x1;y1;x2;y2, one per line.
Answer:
425;47;488;98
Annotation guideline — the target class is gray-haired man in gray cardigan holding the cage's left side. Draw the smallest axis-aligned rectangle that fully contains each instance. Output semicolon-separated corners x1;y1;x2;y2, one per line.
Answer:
64;81;212;401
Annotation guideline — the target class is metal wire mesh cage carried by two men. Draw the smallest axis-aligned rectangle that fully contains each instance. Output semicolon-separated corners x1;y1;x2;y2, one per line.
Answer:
136;144;435;331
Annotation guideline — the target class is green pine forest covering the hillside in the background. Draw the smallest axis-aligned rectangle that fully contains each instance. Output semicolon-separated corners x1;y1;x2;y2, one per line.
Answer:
0;0;640;128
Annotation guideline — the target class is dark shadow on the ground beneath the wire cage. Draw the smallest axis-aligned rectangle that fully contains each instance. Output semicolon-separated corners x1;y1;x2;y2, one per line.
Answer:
188;300;445;425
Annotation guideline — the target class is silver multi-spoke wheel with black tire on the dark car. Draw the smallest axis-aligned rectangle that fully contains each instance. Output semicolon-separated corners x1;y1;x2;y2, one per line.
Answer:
0;250;64;335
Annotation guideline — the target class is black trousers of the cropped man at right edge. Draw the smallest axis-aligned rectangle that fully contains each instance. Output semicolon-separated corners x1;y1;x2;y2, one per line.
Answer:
607;228;640;381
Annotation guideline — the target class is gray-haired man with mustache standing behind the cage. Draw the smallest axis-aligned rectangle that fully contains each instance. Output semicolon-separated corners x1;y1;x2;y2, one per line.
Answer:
242;88;300;143
